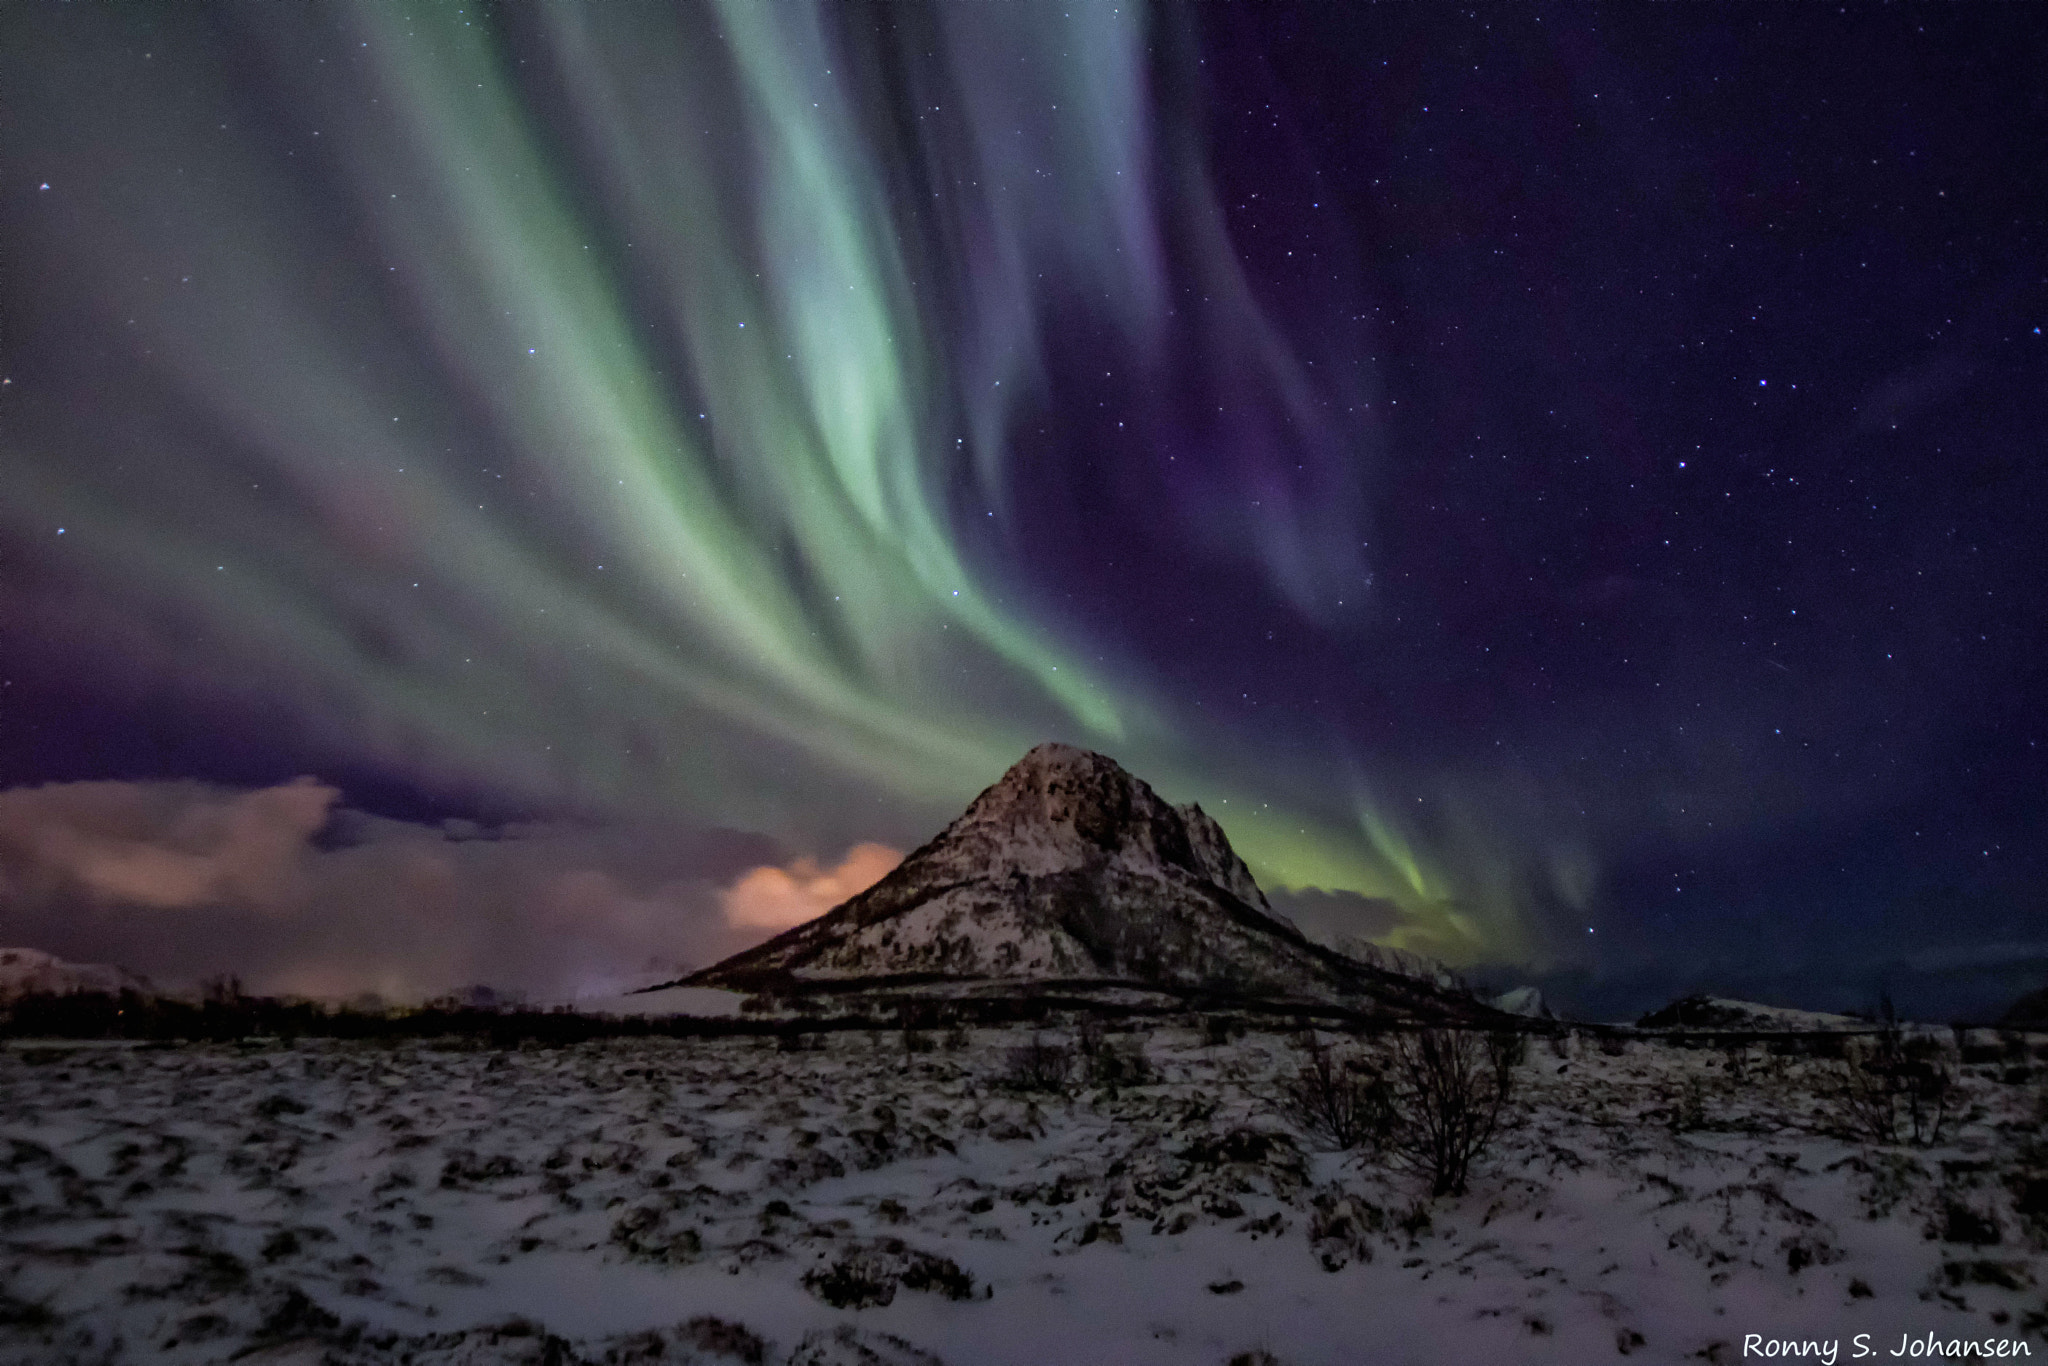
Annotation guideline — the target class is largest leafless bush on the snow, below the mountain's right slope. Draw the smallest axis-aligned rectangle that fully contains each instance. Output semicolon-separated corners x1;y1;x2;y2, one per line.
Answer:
1386;1028;1528;1196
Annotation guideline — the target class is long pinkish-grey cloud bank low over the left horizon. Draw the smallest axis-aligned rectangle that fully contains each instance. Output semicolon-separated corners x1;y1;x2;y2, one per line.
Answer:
0;778;782;1001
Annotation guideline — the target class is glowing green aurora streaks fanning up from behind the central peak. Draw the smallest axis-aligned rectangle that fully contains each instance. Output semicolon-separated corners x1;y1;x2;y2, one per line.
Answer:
0;0;1589;961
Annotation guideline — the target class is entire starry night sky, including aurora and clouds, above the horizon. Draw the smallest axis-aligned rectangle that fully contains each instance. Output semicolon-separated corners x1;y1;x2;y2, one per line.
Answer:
0;0;2048;1016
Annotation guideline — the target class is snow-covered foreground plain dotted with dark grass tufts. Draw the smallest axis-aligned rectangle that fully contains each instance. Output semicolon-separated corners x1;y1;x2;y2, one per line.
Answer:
0;1028;2048;1366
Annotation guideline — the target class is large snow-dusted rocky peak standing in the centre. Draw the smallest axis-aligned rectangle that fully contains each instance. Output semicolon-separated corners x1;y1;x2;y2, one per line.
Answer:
684;745;1499;1020
